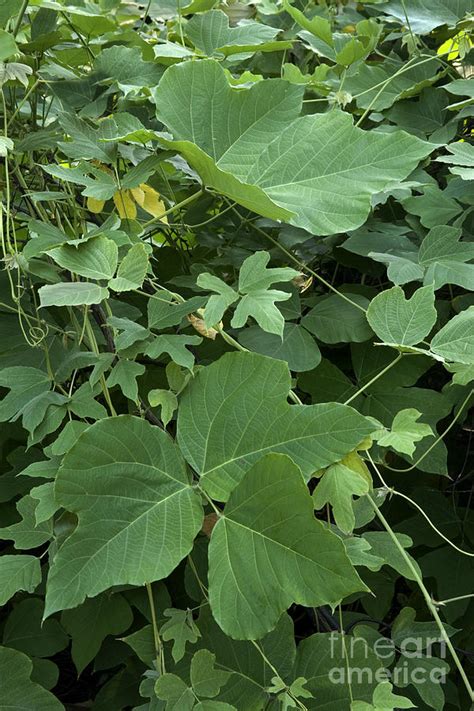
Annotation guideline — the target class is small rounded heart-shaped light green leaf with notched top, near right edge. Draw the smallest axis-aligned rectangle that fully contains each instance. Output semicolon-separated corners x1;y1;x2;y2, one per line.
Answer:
367;285;437;346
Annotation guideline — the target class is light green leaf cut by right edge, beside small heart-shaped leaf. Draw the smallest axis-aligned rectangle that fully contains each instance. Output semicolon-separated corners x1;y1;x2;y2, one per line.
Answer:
430;306;474;365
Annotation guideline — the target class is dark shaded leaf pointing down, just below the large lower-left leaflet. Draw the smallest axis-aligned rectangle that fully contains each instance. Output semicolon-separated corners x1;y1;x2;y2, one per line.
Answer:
61;594;133;674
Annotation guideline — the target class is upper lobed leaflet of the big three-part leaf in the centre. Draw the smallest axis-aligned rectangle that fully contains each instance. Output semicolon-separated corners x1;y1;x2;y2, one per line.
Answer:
178;353;375;501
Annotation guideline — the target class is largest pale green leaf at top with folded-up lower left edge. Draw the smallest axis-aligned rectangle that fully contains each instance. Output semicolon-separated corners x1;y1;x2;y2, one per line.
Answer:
155;60;432;235
